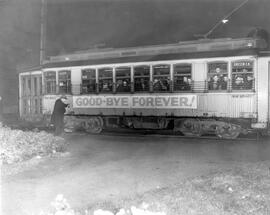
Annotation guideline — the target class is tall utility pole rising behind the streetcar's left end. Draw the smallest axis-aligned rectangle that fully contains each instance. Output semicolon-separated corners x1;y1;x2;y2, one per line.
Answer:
39;0;47;65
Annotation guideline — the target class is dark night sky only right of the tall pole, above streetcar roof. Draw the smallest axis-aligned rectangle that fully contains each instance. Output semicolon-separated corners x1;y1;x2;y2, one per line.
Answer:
47;0;270;54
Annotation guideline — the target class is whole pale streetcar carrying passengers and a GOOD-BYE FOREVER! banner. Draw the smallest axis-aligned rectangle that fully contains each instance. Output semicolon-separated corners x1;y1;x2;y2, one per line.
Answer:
19;37;270;139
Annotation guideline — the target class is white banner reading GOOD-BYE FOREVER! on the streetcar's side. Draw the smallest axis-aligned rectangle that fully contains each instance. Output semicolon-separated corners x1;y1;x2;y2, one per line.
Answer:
73;95;197;109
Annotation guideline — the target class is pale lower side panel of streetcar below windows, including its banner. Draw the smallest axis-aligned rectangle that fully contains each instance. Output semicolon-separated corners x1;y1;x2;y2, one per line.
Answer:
73;93;257;119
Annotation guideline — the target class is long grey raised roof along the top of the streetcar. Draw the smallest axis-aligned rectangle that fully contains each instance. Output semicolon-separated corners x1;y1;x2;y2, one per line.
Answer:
44;38;267;64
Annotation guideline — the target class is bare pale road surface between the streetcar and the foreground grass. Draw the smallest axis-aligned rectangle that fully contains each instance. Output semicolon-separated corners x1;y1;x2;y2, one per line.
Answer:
2;134;270;215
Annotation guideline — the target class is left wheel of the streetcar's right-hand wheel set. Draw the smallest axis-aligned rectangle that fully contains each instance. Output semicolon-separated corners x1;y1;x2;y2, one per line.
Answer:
179;119;202;137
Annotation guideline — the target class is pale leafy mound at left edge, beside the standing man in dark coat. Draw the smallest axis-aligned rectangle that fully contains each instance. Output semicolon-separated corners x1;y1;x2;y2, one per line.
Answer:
0;122;67;164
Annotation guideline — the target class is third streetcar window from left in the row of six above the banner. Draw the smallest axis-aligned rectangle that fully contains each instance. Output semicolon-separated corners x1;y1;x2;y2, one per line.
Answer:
115;67;130;92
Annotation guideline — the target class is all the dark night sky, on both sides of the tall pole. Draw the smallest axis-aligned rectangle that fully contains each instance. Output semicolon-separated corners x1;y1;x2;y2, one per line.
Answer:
0;0;270;105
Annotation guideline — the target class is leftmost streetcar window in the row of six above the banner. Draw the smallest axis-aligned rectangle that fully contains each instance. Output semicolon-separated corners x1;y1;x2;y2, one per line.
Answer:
82;69;96;94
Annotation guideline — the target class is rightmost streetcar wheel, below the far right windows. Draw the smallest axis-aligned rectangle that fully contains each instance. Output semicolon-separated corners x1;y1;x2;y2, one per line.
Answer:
216;123;241;139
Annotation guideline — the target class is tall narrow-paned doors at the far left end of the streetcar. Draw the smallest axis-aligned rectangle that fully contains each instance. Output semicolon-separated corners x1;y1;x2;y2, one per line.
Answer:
21;74;42;121
